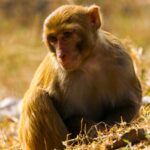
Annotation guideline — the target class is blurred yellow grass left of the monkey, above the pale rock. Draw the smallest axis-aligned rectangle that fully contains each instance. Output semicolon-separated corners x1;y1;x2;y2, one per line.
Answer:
0;20;47;98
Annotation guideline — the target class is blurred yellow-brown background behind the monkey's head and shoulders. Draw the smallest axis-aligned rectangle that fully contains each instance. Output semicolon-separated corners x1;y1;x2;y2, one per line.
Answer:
0;0;150;99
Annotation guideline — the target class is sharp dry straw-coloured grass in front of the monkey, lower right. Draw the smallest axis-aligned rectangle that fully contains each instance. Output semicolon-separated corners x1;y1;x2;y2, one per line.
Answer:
64;105;150;150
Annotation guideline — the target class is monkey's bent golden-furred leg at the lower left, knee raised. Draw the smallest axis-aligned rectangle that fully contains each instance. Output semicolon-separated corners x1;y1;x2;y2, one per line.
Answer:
20;89;67;150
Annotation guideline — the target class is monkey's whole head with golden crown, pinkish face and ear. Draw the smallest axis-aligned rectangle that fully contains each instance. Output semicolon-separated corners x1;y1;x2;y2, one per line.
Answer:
43;5;100;71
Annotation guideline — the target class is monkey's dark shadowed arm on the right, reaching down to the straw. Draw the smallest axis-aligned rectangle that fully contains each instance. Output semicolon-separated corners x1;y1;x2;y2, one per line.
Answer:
88;77;142;138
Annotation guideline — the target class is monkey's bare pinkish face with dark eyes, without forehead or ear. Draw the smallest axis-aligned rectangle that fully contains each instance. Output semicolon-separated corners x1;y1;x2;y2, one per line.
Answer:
47;29;82;70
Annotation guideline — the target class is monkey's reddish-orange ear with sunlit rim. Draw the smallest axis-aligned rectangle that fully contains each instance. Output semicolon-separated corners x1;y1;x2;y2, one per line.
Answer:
88;5;101;29
